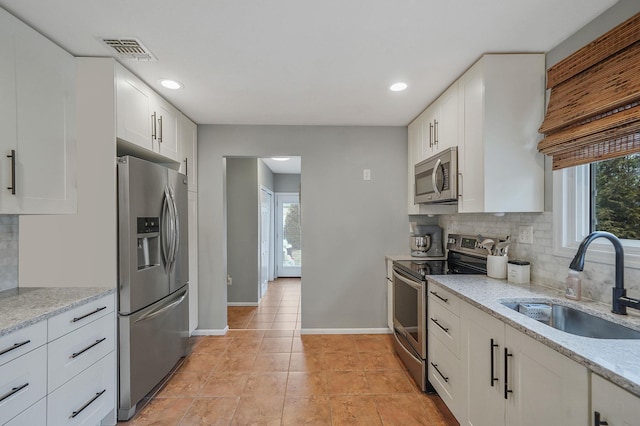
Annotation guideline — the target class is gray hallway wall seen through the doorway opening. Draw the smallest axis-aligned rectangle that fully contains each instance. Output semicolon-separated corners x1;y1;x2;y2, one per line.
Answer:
227;158;260;304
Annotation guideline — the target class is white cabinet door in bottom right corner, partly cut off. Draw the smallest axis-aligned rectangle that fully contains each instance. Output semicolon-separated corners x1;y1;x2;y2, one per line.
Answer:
590;374;640;426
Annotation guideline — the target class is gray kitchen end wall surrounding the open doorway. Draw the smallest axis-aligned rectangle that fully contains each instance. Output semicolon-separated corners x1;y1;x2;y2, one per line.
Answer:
198;125;408;331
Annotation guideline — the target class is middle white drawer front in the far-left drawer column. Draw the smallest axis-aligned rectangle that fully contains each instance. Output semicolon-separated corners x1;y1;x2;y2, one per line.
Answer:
0;346;47;424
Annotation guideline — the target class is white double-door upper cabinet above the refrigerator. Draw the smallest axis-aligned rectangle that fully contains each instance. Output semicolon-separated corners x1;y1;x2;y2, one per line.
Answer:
116;65;180;162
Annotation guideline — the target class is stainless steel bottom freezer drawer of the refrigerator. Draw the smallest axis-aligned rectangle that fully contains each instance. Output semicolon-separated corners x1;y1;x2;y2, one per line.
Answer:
118;286;189;420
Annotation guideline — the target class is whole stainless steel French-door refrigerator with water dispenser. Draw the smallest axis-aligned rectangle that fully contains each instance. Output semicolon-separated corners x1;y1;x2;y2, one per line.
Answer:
117;156;189;420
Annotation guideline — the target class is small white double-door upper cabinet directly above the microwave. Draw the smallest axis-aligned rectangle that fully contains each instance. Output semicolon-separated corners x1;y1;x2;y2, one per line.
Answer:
421;82;458;160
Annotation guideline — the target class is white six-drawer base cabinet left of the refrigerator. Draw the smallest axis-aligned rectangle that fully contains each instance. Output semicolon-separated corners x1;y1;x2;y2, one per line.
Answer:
0;294;116;426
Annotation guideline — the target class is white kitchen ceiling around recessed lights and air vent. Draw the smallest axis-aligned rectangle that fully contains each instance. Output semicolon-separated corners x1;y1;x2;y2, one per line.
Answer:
0;0;616;125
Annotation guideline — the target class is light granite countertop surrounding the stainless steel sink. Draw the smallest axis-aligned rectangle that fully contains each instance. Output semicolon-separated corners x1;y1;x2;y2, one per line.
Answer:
428;275;640;396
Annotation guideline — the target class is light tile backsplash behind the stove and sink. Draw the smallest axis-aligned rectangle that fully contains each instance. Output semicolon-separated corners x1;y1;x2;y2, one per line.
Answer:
439;213;640;303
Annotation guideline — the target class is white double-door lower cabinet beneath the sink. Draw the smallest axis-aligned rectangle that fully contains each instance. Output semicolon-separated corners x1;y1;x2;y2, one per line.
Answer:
459;303;589;426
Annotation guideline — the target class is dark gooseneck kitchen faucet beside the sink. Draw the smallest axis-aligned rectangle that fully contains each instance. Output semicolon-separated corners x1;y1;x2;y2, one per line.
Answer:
569;231;640;315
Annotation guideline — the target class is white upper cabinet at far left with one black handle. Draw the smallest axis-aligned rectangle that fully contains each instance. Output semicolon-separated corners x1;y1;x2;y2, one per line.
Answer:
0;9;77;214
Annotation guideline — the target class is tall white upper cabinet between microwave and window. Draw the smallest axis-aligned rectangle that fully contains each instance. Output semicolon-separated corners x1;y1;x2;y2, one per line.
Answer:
458;54;545;213
